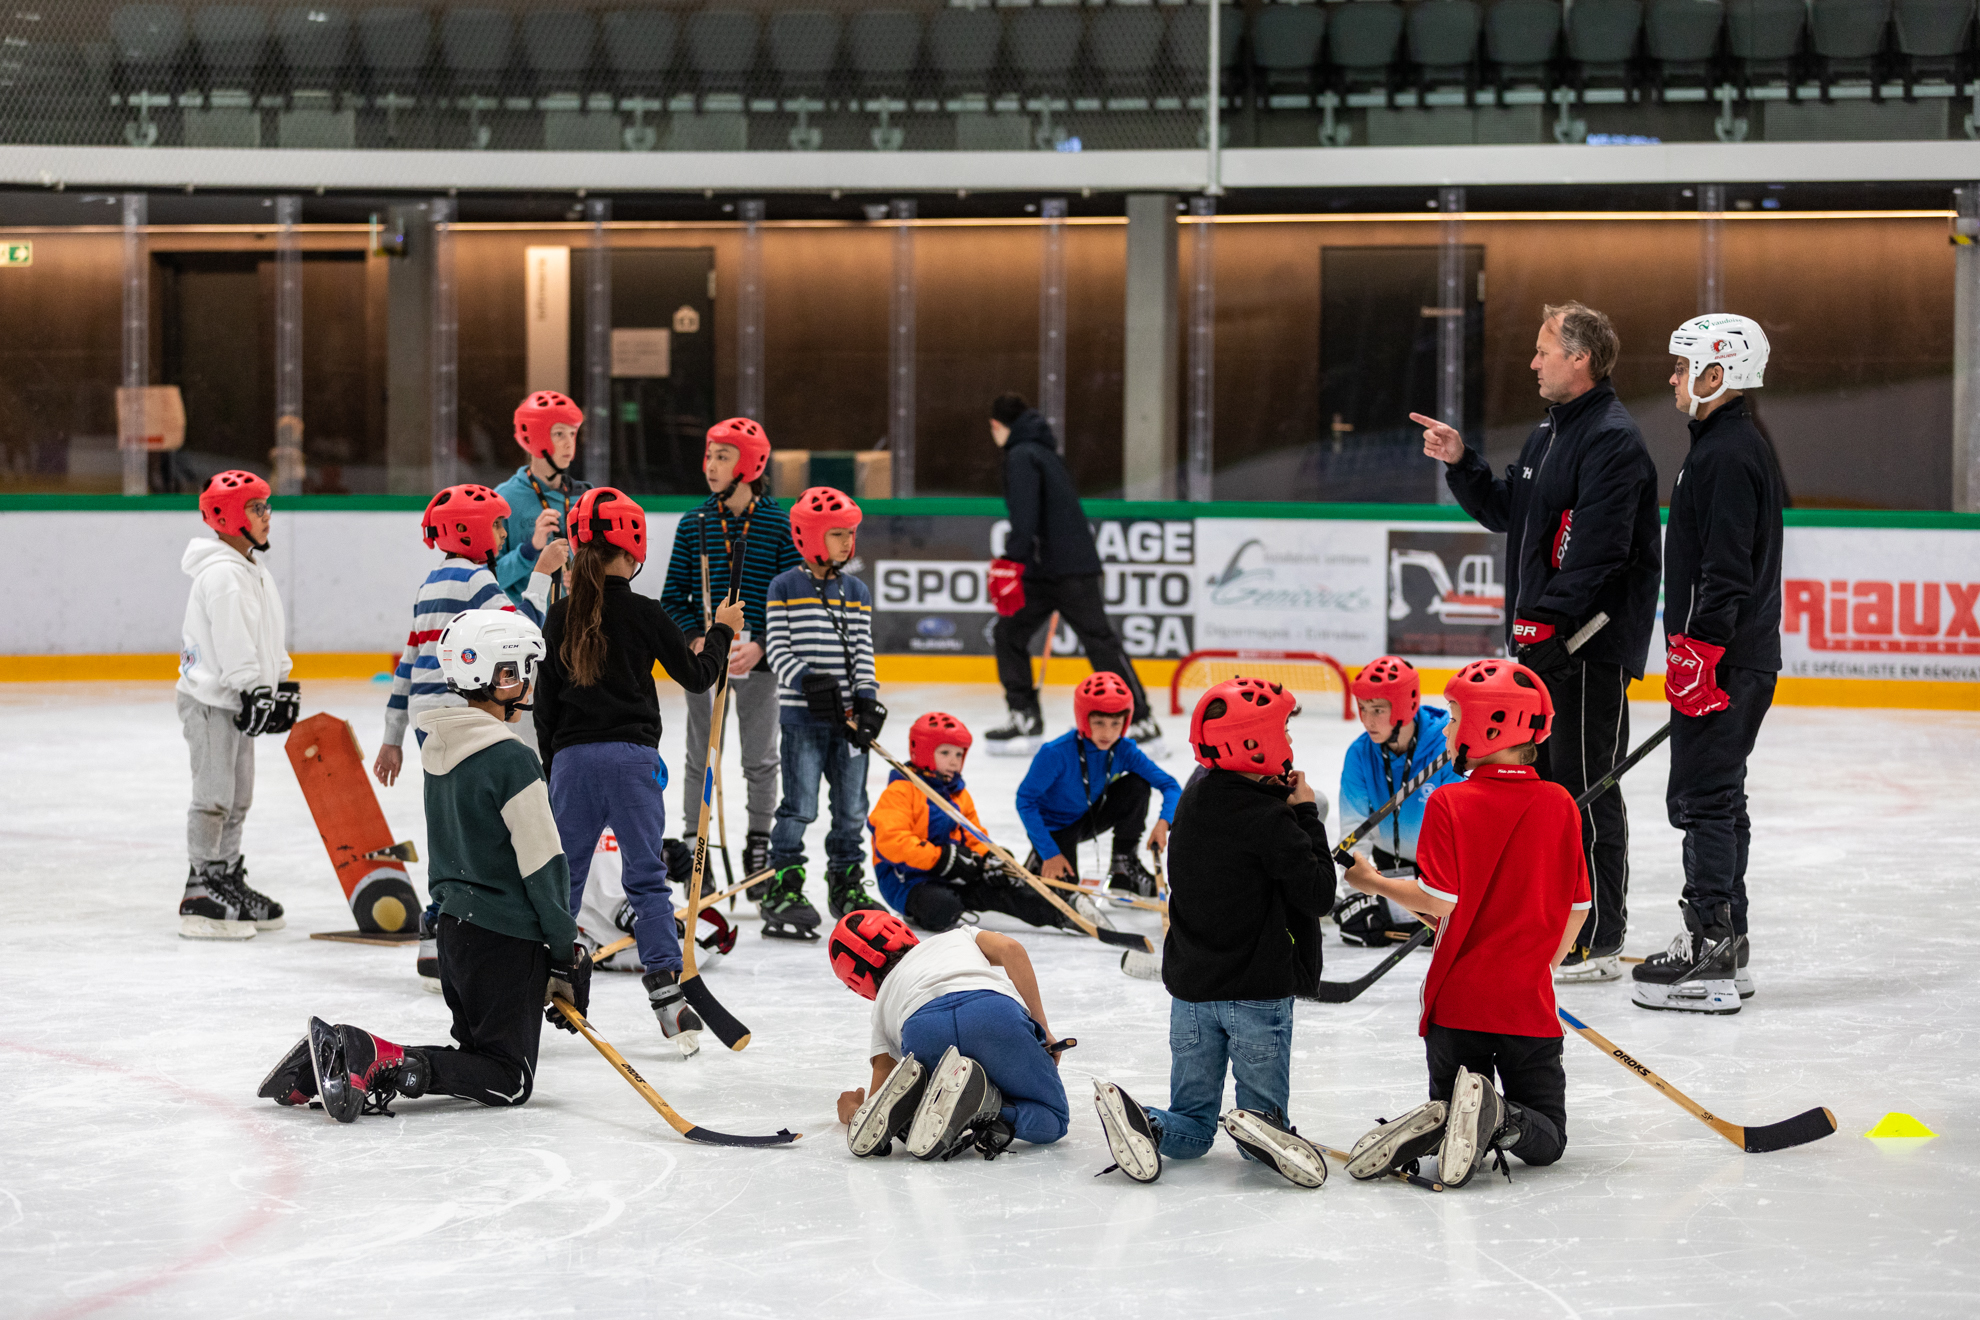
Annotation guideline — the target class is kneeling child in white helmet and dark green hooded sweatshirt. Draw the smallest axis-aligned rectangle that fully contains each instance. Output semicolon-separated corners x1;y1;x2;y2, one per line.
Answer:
257;610;592;1122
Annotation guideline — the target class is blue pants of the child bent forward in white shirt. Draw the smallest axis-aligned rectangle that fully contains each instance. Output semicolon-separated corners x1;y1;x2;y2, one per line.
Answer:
901;990;1071;1146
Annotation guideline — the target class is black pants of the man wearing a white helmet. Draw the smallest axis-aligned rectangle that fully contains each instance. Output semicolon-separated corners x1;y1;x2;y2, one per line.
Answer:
1665;669;1776;934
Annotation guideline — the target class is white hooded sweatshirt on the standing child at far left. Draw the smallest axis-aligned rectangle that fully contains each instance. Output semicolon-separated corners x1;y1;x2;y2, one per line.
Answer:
178;536;291;710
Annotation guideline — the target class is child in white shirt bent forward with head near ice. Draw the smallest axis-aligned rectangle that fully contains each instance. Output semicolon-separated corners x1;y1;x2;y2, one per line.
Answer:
826;908;1073;1160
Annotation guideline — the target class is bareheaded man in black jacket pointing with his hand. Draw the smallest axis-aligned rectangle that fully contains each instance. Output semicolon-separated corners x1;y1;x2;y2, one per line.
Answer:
1412;303;1659;982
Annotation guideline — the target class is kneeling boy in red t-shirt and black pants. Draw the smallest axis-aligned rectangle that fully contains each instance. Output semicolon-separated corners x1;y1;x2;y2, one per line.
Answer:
1344;659;1590;1187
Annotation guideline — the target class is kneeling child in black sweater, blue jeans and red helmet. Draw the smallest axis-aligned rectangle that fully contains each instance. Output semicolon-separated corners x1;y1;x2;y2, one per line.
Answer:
1093;679;1335;1187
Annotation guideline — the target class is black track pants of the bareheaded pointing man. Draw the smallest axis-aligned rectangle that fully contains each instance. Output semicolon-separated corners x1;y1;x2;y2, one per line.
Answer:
1536;663;1630;952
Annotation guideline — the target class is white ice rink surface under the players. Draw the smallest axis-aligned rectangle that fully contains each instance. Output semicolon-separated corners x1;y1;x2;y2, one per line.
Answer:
0;680;1980;1318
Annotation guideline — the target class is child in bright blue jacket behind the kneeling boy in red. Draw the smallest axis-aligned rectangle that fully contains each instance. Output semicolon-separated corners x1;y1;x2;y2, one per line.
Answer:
1335;655;1463;948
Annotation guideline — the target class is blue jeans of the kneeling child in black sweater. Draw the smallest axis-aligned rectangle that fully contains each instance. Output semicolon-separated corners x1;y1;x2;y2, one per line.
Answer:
1148;999;1293;1160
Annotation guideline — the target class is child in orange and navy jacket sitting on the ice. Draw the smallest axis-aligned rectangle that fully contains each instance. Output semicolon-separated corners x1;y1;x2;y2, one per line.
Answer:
867;710;1063;930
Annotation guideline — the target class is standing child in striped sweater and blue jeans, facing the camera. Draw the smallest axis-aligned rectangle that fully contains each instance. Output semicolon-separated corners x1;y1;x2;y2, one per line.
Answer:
758;487;887;940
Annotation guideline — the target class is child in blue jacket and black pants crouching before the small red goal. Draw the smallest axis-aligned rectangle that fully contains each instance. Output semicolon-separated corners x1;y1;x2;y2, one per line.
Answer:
1018;671;1182;896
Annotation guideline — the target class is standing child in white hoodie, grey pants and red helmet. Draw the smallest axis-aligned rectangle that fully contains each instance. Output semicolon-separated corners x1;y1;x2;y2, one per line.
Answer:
178;471;303;940
